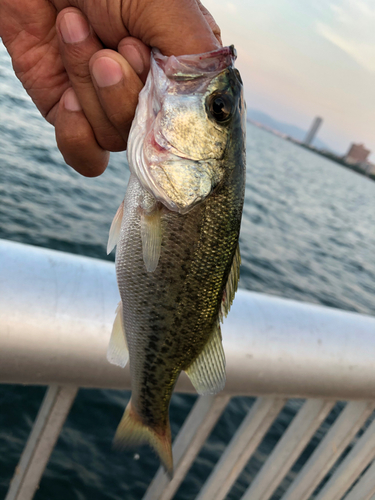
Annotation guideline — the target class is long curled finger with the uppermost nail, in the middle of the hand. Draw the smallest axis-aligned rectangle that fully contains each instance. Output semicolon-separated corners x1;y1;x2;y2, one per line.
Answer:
56;7;126;151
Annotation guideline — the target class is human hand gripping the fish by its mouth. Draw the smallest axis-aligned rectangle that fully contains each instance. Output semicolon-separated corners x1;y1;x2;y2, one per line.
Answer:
0;0;220;177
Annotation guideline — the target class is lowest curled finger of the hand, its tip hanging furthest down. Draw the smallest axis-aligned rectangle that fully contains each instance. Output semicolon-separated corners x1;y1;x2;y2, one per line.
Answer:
55;88;109;177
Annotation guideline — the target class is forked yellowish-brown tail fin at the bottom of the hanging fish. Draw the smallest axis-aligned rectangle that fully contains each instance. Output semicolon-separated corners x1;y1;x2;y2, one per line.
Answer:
114;400;173;479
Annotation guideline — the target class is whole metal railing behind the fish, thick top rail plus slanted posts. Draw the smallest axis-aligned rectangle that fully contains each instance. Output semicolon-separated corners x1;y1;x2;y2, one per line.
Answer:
0;240;375;500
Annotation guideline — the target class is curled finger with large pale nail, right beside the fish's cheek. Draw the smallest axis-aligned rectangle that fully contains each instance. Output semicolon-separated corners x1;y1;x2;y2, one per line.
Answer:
90;49;143;143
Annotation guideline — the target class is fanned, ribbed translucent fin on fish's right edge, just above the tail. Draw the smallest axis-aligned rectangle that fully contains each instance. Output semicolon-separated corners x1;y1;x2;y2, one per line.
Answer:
185;321;225;395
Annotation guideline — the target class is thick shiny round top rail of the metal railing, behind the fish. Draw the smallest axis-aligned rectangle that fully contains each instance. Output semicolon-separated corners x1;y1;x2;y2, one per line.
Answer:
0;240;375;400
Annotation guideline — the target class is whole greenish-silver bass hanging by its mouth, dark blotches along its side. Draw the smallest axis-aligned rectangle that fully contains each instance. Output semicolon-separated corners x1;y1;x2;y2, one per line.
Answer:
107;47;245;475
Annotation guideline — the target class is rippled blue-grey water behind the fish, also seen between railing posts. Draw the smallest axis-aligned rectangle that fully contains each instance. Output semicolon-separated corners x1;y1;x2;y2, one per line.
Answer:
0;44;375;500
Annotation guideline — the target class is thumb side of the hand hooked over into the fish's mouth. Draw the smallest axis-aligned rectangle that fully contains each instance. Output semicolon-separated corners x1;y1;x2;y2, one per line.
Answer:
50;0;221;56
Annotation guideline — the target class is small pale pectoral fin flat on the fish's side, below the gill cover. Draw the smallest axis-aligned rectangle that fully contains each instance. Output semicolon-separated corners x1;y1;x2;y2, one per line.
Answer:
141;208;162;273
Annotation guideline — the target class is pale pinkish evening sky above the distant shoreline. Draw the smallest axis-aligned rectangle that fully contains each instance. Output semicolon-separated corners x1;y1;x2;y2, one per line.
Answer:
203;0;375;162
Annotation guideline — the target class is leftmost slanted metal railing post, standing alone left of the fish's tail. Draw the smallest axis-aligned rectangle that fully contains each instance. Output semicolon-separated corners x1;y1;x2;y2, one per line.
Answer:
5;385;78;500
